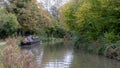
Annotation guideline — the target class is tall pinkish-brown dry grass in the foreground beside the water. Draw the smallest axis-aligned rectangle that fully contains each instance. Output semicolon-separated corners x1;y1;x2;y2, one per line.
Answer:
1;38;40;68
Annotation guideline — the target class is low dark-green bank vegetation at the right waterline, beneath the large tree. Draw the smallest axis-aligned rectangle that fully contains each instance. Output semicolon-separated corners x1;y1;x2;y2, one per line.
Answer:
74;41;120;61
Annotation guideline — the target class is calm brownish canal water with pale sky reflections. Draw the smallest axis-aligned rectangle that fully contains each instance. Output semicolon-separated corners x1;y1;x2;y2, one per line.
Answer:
23;43;120;68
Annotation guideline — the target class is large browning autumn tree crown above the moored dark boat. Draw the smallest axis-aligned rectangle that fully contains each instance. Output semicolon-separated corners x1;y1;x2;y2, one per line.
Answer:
6;0;51;33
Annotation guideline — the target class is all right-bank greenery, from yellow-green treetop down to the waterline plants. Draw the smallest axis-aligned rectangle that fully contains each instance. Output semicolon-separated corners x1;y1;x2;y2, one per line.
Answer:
61;0;120;57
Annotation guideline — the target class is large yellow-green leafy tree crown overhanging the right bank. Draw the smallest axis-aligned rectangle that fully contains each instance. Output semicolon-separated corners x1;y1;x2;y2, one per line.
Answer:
62;0;120;42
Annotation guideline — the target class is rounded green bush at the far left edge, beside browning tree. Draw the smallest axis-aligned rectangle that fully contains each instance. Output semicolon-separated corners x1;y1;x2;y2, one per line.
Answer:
0;9;19;38
